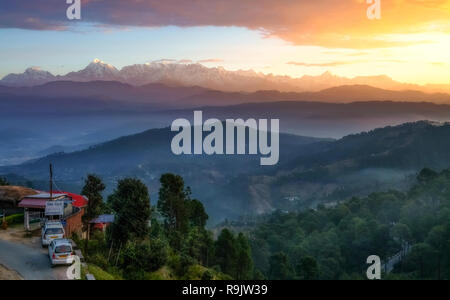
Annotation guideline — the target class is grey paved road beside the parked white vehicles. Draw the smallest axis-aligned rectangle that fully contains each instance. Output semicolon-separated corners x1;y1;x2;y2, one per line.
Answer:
0;239;67;280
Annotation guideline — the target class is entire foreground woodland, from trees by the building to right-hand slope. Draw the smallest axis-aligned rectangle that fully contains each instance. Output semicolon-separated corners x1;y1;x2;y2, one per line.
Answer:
1;169;450;280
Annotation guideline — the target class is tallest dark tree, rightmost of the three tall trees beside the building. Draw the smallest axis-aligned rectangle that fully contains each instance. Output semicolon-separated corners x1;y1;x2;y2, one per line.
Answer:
158;174;190;233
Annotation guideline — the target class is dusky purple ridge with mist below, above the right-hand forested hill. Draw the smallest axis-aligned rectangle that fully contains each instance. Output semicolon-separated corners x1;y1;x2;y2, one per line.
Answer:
169;101;450;138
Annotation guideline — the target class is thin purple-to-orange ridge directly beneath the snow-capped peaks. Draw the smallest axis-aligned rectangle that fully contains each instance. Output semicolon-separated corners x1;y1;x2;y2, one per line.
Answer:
0;80;450;108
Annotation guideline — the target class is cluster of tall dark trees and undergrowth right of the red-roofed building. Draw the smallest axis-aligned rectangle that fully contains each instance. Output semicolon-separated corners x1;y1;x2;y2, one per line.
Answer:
76;174;254;280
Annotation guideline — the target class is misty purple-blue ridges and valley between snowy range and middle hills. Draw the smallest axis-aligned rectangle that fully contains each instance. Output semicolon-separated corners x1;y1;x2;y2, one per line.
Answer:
0;81;450;165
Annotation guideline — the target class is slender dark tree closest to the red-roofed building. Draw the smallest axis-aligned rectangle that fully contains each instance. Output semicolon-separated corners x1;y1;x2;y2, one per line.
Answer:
81;174;106;253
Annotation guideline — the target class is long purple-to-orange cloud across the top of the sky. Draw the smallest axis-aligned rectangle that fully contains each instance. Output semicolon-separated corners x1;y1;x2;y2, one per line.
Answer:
0;0;450;49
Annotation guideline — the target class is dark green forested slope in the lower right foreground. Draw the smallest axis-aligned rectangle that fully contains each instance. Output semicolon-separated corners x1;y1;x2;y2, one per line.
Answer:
249;169;450;279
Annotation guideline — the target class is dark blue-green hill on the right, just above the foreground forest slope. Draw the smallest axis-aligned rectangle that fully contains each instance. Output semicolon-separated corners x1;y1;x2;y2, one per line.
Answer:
234;121;450;213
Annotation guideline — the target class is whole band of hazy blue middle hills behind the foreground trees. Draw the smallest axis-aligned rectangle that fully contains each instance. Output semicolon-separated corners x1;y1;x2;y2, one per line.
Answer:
0;121;450;221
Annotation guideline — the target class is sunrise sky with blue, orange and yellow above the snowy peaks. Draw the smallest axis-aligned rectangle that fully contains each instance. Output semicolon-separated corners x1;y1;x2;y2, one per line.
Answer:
0;0;450;84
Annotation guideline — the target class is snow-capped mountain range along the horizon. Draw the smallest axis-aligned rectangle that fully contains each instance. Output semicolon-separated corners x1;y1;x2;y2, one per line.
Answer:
0;59;450;92
